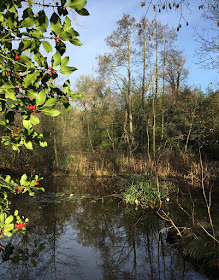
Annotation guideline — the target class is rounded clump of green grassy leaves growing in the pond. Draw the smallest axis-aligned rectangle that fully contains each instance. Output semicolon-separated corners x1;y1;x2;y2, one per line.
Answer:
123;176;169;208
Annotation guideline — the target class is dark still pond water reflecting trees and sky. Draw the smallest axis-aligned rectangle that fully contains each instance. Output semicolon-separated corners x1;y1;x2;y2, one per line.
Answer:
0;176;213;280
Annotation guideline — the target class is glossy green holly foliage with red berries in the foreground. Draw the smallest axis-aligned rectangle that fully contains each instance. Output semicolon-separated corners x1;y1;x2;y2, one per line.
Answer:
0;0;89;243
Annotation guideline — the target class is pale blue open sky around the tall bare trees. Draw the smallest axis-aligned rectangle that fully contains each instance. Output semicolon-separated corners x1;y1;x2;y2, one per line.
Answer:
69;0;219;91
